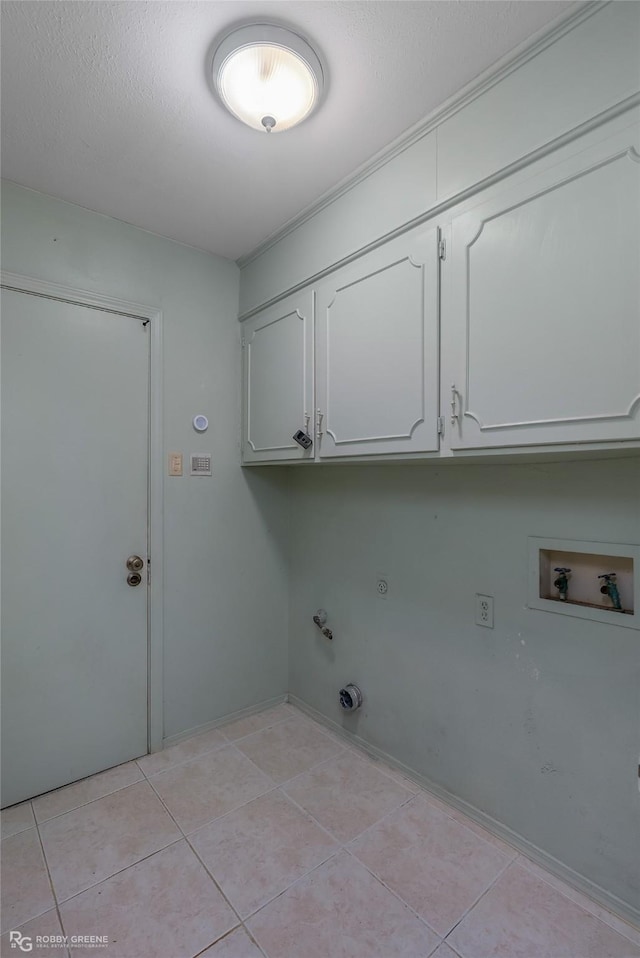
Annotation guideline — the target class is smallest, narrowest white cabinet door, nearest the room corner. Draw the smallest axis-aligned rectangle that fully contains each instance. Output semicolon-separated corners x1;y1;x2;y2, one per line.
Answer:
242;290;313;462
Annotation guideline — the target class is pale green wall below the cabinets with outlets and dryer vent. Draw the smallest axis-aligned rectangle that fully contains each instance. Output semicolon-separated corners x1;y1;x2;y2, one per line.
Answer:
290;459;640;909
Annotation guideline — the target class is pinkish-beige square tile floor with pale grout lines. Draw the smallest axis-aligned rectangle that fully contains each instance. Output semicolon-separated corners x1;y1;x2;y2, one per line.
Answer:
0;704;640;958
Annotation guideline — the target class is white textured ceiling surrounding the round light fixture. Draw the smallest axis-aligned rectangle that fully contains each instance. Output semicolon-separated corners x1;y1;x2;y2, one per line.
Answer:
2;0;574;259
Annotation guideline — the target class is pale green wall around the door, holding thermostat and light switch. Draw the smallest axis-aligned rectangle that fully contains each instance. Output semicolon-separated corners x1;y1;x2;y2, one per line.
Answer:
2;183;287;737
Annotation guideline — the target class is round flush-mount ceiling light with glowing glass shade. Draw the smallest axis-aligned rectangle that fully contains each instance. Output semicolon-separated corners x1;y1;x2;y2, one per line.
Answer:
213;23;324;133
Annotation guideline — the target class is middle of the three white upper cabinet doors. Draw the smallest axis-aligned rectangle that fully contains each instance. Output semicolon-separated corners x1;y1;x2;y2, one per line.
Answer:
316;228;438;459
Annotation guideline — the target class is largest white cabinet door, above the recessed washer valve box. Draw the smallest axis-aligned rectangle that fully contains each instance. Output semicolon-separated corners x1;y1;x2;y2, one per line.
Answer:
442;118;640;449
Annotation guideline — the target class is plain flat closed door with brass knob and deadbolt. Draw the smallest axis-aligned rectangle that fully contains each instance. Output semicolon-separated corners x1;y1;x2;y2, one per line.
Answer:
2;290;150;806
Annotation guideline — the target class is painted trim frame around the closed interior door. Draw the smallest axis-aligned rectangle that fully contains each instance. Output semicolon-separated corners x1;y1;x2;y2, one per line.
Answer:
0;270;164;752
